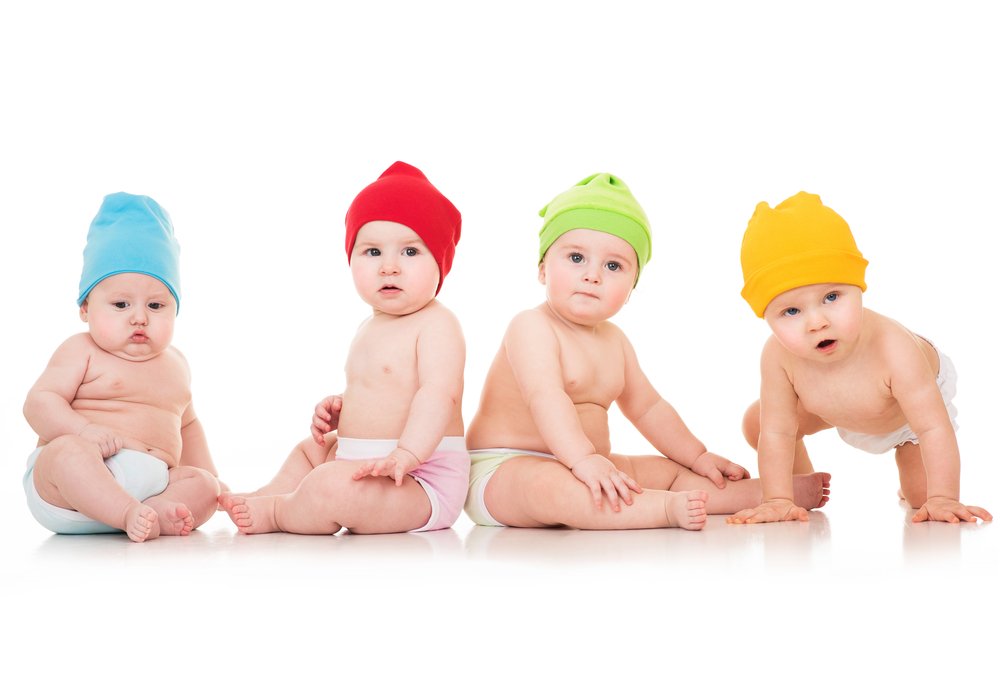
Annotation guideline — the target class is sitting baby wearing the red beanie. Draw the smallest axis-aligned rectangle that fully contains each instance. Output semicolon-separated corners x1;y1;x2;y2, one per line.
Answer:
220;162;469;534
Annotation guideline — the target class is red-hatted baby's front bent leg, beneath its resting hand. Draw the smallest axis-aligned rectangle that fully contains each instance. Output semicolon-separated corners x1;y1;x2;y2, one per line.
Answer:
227;461;431;534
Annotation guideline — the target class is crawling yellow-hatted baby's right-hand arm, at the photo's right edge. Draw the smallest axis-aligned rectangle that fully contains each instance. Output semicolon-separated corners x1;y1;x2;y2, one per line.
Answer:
886;344;993;522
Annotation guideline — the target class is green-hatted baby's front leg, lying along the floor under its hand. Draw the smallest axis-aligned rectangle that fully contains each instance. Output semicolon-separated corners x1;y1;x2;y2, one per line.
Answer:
484;456;706;530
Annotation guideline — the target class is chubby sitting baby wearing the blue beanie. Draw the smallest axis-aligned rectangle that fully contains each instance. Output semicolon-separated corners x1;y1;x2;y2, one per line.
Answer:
23;193;219;542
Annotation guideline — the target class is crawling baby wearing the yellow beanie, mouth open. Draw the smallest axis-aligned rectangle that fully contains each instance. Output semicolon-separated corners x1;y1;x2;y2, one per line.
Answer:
728;193;992;524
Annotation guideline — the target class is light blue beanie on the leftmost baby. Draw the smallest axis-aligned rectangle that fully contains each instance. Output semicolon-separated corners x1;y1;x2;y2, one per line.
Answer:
76;193;181;310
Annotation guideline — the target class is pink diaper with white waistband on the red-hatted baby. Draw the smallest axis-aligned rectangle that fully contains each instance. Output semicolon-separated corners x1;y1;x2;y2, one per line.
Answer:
337;437;469;531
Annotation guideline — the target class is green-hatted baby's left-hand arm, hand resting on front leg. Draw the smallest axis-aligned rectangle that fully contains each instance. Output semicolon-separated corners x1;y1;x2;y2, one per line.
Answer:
503;311;642;511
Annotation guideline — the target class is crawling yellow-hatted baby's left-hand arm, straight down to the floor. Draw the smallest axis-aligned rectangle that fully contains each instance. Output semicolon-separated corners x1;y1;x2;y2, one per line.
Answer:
726;341;809;524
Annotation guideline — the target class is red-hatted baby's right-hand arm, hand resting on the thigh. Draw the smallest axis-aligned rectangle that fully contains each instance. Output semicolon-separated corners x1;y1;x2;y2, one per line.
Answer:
354;312;465;486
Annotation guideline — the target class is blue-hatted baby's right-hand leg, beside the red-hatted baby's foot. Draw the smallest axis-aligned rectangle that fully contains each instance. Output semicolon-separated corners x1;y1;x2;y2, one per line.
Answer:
143;466;219;536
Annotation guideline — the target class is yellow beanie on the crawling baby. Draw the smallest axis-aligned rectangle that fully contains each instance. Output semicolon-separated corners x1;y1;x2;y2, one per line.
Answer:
740;193;868;317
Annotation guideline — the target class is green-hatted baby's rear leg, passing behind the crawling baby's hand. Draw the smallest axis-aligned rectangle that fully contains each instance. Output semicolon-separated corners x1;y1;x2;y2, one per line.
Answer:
611;454;830;515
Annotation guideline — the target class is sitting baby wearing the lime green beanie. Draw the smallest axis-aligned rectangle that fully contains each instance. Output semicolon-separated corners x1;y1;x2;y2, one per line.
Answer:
465;174;829;530
